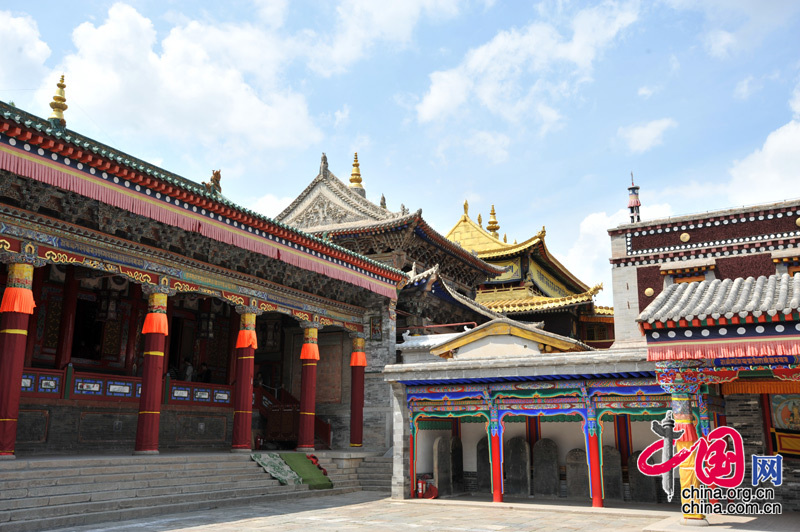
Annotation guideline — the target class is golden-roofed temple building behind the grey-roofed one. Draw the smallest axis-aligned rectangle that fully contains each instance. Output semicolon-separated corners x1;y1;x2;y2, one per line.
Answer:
447;202;614;349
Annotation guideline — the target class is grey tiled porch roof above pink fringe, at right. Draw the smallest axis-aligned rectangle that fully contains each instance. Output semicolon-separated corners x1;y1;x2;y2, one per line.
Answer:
637;272;800;323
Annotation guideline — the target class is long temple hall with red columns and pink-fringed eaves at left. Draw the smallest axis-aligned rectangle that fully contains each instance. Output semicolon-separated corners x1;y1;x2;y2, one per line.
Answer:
0;77;406;457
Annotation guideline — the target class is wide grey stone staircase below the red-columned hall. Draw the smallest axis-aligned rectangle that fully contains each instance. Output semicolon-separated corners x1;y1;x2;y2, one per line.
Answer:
0;453;359;532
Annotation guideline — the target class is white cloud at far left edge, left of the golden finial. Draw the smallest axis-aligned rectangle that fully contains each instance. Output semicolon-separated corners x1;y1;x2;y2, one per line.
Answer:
0;11;50;106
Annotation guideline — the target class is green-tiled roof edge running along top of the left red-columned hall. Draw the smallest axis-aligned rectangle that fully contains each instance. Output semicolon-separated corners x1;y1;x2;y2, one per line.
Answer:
0;102;405;279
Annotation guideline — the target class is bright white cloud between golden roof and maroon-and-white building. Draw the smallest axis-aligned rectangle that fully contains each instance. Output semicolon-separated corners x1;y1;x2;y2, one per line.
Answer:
557;201;673;305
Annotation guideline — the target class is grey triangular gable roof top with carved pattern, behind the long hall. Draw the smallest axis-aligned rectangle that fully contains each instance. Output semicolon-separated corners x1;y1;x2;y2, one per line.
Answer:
275;153;401;232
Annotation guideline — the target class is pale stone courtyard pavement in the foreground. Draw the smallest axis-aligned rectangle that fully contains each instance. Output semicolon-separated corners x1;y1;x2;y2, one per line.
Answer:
54;492;800;532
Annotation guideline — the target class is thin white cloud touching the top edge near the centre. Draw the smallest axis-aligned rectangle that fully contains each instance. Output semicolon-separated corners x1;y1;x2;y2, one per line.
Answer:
305;0;461;76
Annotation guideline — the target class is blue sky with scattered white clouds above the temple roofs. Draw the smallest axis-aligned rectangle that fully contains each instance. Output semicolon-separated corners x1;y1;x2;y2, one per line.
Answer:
0;0;800;304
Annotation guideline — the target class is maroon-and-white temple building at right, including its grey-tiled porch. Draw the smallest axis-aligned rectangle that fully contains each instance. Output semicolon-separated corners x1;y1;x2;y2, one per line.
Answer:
609;194;800;519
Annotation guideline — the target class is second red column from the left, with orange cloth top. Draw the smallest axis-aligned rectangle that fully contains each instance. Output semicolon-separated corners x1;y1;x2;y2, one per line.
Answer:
134;285;169;454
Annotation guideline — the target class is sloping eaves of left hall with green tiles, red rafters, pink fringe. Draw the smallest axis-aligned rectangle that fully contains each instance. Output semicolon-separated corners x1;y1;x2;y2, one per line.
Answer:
0;102;406;297
